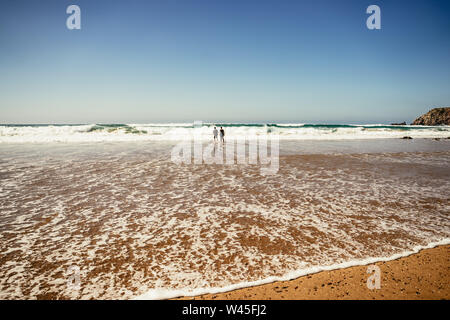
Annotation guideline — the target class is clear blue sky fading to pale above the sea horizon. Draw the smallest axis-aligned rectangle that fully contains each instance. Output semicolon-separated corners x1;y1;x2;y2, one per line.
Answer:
0;0;450;124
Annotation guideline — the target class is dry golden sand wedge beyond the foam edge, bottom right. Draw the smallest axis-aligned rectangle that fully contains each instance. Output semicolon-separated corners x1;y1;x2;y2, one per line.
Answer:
180;245;450;300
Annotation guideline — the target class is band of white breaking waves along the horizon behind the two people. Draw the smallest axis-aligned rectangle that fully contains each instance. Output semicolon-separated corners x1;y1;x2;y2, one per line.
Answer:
0;123;450;143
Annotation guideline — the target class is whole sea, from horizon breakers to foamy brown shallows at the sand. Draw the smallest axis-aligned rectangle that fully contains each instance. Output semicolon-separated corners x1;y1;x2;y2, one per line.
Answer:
0;123;450;299
